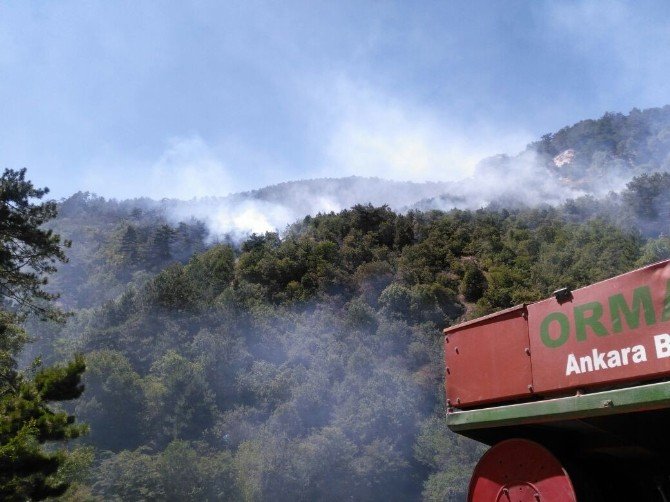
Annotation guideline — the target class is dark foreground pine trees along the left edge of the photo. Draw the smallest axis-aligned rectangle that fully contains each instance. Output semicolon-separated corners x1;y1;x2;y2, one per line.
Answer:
0;169;85;500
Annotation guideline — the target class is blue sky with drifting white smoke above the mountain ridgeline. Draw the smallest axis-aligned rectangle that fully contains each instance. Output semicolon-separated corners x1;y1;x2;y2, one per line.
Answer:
0;0;670;199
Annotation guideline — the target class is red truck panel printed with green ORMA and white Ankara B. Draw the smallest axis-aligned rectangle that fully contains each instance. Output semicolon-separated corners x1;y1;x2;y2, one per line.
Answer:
528;261;670;393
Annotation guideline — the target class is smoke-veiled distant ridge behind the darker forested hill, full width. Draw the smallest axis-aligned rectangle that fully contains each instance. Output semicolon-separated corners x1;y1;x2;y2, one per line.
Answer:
48;106;670;308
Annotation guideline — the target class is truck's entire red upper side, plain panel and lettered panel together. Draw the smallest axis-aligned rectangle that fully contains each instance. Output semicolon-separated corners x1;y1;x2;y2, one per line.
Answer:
444;260;670;409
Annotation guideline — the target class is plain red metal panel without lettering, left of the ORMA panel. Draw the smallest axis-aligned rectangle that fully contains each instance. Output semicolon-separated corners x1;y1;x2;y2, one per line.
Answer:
444;306;532;408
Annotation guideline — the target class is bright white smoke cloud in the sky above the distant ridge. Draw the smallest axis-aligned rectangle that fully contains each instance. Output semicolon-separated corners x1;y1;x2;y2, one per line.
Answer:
317;75;531;181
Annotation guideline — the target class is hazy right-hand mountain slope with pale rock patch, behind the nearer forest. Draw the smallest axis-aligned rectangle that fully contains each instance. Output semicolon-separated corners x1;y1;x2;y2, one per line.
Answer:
412;106;670;210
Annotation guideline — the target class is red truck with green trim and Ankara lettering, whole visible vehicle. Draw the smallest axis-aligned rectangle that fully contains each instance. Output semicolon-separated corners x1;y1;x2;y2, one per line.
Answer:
444;260;670;502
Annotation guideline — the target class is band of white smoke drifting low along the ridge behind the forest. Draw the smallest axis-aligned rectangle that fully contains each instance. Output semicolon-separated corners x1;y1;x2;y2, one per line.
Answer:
164;150;630;241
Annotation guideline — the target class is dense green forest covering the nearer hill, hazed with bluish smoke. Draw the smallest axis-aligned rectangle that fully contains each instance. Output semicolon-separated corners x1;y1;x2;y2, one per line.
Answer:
3;106;670;501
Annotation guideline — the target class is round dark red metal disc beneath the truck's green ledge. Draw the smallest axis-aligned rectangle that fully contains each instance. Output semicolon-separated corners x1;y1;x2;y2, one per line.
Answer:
468;439;577;502
